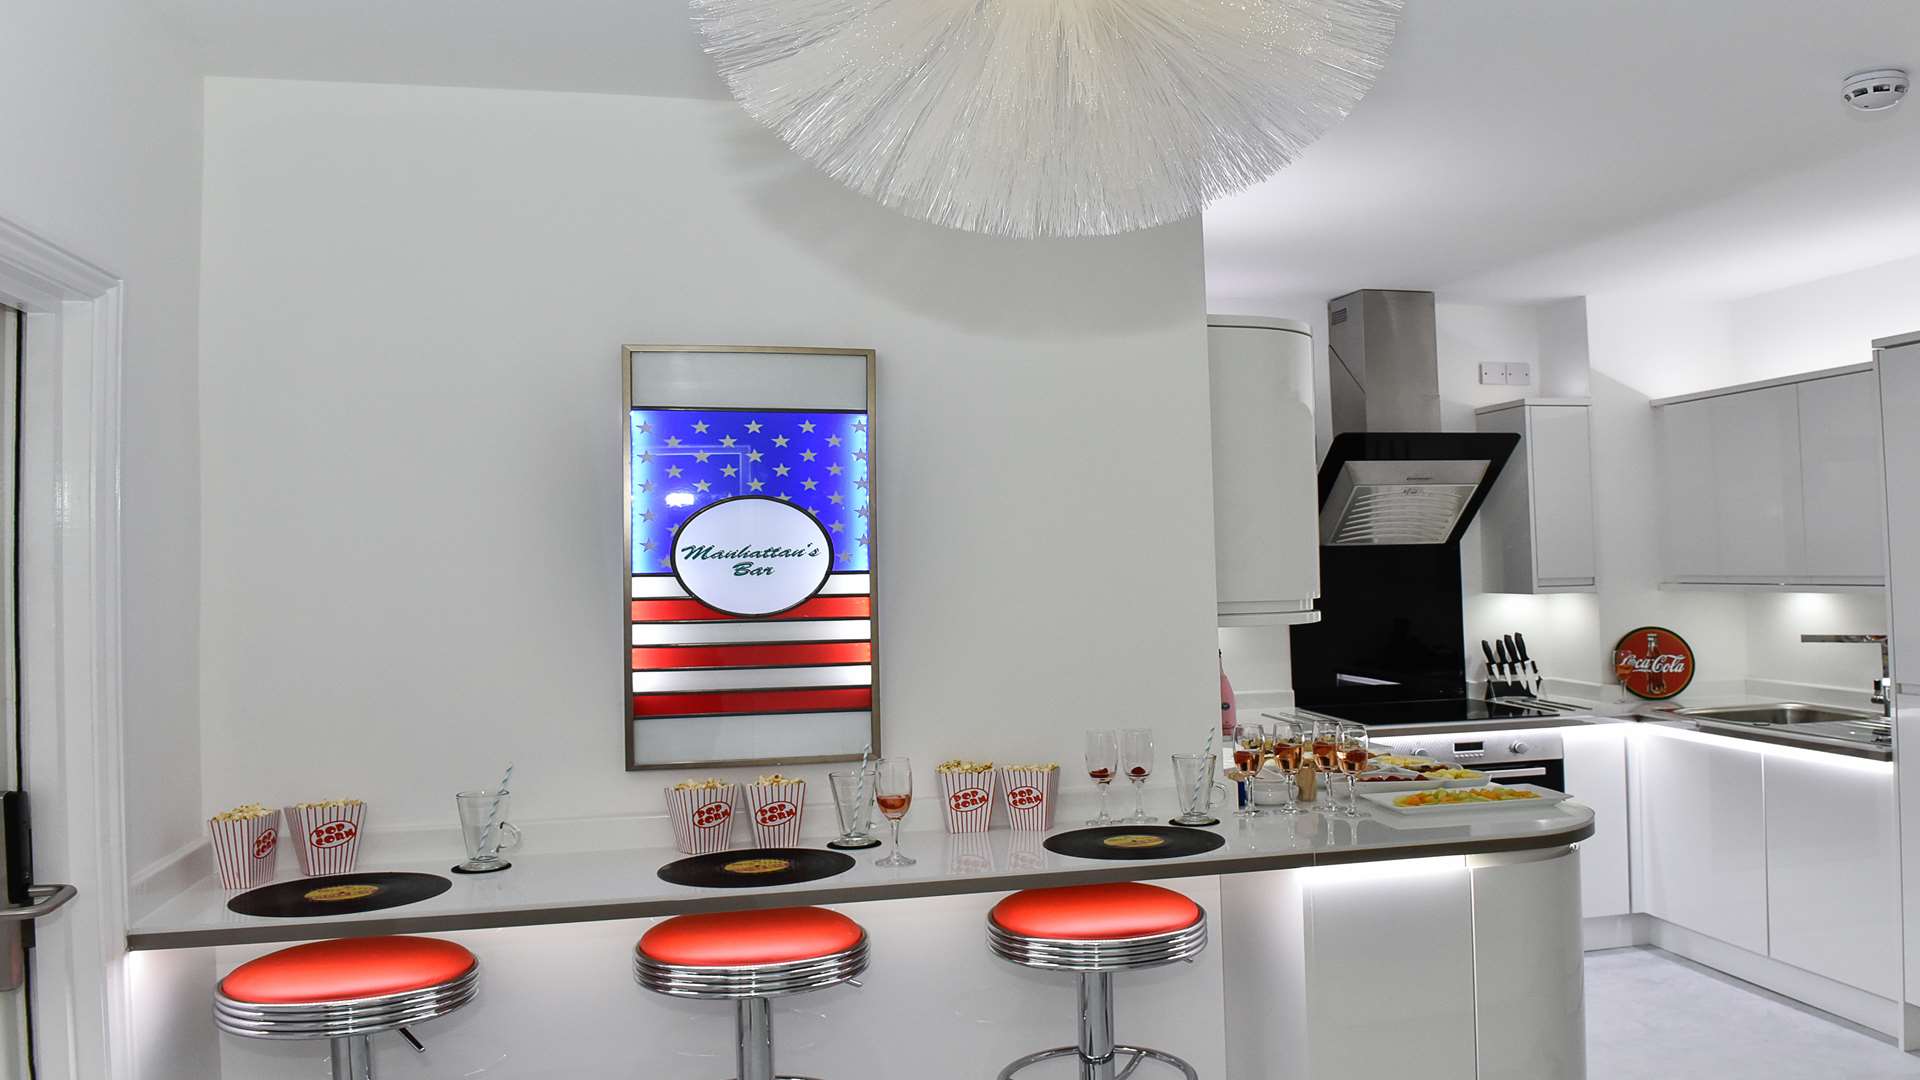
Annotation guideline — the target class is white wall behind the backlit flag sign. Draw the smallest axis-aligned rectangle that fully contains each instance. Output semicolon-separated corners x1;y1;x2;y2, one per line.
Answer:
202;79;1217;824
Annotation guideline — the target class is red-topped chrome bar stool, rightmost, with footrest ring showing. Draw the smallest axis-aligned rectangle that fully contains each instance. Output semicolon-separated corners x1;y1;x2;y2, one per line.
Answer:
987;882;1206;1080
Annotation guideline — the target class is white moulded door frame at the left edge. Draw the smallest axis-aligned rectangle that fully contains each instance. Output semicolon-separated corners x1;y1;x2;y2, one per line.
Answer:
0;219;134;1080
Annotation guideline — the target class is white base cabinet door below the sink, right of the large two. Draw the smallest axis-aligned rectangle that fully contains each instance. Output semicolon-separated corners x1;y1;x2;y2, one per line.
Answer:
1763;755;1901;997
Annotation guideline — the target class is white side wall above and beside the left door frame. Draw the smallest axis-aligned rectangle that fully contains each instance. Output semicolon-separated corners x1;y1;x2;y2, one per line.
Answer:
0;0;205;883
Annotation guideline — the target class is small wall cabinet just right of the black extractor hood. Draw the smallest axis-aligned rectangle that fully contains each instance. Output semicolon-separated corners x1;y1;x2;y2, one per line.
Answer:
1476;398;1594;592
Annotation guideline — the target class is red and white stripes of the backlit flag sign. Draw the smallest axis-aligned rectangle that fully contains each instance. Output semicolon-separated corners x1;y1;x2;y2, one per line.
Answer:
630;573;874;719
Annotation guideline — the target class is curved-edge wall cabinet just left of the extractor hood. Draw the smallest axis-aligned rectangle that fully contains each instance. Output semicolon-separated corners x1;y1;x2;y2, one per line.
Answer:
1208;315;1319;626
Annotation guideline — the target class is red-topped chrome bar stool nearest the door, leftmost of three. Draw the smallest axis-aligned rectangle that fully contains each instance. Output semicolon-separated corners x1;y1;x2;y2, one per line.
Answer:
213;938;480;1080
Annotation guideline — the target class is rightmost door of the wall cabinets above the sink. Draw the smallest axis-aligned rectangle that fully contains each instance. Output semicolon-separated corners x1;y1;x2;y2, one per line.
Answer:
1799;371;1887;584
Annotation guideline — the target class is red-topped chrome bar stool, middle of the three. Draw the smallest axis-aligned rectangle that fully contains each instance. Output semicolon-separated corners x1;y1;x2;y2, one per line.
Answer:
634;907;866;1080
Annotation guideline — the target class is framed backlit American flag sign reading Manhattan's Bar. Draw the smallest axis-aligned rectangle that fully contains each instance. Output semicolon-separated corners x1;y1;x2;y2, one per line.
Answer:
622;346;879;769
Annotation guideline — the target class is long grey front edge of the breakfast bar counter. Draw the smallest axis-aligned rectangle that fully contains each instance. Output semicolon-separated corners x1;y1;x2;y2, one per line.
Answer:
127;819;1594;951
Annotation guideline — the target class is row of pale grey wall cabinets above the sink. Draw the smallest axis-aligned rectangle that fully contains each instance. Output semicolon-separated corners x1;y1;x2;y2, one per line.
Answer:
1653;365;1885;588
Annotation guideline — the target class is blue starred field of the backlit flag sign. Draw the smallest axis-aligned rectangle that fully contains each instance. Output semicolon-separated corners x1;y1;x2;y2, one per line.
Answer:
630;409;874;575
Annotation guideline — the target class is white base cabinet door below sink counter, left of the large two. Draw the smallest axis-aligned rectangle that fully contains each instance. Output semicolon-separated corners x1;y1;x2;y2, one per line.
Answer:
1634;728;1766;955
